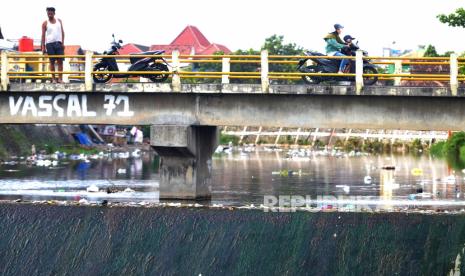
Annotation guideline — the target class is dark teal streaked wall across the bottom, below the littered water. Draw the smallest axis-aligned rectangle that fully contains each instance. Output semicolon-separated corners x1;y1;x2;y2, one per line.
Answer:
0;204;465;275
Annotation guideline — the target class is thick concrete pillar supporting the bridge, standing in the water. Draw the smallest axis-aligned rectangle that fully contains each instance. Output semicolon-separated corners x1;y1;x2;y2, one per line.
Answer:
151;125;219;199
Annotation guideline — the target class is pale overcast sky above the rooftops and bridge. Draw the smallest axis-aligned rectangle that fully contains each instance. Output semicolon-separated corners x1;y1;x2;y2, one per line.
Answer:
0;0;465;55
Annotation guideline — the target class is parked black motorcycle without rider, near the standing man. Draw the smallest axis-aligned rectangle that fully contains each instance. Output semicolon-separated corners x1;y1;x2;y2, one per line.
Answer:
93;35;169;83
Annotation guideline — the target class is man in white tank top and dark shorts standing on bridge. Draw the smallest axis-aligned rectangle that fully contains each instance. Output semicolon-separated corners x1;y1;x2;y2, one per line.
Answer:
41;7;65;83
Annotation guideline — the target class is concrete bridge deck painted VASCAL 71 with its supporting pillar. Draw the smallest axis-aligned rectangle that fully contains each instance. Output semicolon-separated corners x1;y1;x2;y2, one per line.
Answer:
0;83;465;199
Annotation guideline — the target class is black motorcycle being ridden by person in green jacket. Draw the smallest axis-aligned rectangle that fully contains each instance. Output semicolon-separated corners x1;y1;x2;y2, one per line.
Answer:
297;43;378;85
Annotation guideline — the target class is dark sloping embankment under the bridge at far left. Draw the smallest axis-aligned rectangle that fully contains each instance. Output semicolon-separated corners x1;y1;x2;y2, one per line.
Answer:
0;125;78;159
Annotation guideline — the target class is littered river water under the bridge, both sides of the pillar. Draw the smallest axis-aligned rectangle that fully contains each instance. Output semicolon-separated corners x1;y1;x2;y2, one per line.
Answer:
0;150;465;210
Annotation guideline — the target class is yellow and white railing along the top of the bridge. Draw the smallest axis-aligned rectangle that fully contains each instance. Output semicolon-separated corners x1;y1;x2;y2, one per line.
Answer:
0;50;465;94
